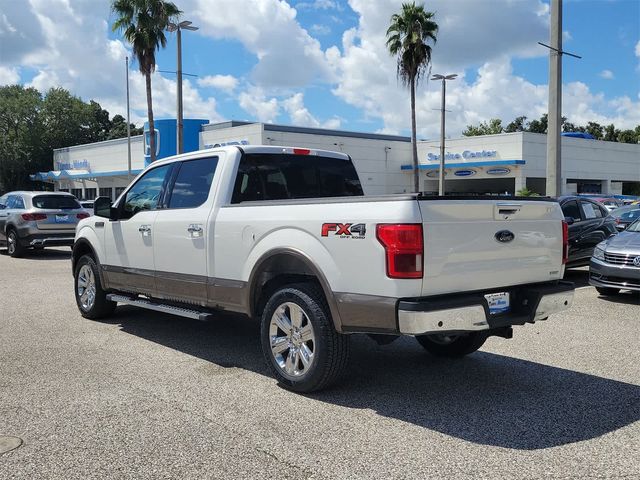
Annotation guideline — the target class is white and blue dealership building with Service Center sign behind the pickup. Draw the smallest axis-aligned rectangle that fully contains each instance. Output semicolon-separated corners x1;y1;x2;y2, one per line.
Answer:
31;119;640;199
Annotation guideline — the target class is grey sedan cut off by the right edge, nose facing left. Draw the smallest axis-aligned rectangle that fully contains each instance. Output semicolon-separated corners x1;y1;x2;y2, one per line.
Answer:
589;218;640;295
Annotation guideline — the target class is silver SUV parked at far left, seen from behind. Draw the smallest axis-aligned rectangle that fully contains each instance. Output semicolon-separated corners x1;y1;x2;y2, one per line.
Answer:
0;192;89;257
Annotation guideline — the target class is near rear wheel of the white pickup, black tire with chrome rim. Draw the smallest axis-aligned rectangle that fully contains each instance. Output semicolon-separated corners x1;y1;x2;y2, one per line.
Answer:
260;283;349;392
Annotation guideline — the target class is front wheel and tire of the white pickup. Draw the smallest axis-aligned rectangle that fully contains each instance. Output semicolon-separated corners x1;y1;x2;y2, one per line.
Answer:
74;255;117;320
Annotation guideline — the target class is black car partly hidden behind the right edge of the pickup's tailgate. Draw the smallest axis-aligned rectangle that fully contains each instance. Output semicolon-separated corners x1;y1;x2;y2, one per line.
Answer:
558;196;618;268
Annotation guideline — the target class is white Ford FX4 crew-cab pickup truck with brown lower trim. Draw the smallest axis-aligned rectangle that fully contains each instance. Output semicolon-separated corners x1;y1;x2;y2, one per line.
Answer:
72;146;574;392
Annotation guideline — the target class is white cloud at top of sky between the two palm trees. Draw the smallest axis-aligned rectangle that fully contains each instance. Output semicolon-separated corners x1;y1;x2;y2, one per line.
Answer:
186;0;331;88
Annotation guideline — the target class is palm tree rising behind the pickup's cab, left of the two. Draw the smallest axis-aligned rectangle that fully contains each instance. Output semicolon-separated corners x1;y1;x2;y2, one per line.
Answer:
111;0;182;162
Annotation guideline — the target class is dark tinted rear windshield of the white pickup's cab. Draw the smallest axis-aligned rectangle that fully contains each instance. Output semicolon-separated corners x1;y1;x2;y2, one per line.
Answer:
232;154;364;203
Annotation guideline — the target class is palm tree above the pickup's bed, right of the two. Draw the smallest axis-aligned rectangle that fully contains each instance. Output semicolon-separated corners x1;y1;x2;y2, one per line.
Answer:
387;2;438;192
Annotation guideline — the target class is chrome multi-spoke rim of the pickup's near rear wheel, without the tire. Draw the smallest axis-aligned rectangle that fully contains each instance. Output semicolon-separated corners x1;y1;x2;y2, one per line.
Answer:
269;302;316;378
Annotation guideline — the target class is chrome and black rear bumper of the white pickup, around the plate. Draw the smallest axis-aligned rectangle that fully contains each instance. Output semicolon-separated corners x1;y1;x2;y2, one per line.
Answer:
398;282;574;335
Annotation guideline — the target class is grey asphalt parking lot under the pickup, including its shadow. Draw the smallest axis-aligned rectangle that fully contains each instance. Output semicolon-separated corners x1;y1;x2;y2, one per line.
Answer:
0;249;640;479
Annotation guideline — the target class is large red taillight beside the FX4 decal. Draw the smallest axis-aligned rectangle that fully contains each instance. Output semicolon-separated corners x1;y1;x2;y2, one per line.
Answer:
376;223;423;278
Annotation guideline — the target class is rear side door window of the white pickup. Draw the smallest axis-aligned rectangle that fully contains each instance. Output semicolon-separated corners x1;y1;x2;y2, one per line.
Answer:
169;157;218;208
